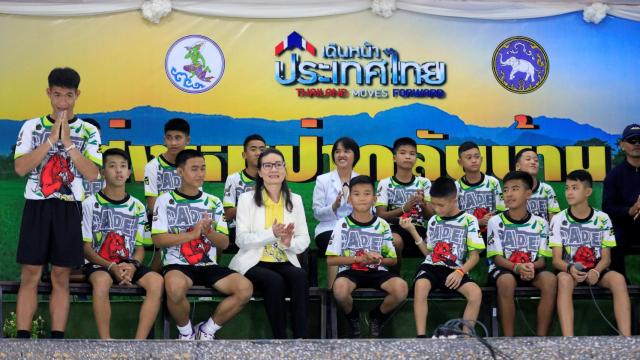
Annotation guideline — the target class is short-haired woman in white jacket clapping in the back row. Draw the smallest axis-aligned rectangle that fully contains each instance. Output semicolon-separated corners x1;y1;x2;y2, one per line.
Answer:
313;137;360;288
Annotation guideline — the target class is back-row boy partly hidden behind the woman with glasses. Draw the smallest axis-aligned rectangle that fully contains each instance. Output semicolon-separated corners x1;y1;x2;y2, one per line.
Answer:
222;134;267;252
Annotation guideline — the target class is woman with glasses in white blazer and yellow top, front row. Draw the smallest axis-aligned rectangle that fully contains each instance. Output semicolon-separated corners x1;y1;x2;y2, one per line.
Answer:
229;149;309;339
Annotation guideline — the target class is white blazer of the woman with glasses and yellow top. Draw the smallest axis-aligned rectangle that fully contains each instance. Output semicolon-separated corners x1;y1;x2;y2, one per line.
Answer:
229;191;309;275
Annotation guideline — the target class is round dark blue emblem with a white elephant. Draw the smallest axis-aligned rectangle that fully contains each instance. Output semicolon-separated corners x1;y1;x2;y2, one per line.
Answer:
491;36;549;94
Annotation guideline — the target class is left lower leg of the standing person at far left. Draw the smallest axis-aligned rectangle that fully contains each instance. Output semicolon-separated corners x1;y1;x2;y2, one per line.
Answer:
16;265;42;331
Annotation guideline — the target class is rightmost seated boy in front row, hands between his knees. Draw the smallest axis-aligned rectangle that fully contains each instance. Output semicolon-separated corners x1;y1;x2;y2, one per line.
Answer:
549;170;631;336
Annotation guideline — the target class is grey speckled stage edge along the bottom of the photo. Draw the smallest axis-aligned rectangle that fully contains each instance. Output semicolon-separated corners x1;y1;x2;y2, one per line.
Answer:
0;336;640;360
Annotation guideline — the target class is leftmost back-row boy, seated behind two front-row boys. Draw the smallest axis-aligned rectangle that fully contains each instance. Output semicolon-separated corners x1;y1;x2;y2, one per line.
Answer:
144;118;191;271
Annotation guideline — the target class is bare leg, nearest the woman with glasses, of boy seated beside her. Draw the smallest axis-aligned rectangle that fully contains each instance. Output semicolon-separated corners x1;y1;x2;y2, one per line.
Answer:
211;272;253;326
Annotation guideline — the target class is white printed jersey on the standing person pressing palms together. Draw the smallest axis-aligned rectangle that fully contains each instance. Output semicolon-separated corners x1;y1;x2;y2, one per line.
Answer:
14;116;102;201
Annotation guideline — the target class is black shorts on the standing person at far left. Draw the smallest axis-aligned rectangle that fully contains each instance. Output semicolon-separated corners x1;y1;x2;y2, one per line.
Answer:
16;199;84;267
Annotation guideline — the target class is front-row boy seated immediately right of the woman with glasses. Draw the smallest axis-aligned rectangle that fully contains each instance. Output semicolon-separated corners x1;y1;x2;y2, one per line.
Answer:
326;175;408;338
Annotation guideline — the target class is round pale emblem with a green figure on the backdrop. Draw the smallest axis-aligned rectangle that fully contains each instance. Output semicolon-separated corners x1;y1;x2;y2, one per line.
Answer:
164;35;224;94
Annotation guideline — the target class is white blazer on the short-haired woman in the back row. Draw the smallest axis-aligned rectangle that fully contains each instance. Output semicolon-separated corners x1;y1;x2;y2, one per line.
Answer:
313;170;358;236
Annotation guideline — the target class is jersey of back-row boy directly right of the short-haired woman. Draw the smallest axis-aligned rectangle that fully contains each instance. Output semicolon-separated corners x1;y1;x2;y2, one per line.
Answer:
376;176;431;226
